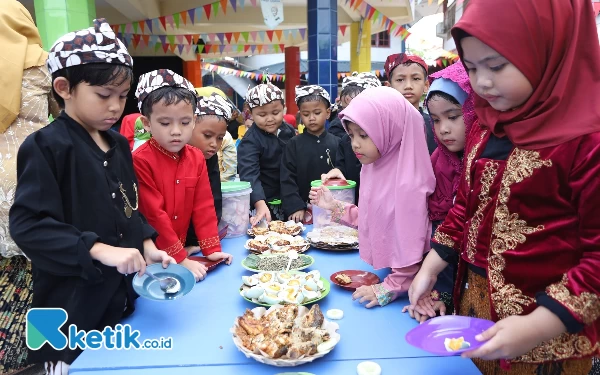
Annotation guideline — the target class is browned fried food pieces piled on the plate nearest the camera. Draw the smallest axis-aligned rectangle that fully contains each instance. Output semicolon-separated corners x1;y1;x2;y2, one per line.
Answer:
234;305;337;359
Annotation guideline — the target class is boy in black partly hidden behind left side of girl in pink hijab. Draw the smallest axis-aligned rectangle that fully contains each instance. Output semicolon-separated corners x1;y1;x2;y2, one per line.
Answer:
329;72;381;206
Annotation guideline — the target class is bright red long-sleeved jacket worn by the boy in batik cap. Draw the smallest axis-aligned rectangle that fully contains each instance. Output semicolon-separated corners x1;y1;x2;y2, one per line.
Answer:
133;138;221;263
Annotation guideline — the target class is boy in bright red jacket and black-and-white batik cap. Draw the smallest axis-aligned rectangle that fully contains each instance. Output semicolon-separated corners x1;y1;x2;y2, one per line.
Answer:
133;69;232;281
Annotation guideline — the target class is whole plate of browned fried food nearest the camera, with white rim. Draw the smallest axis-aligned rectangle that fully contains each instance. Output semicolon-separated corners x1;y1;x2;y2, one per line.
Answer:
230;305;340;367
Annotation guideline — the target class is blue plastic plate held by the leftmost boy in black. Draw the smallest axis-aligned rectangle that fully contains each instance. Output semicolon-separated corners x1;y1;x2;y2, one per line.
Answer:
133;263;196;301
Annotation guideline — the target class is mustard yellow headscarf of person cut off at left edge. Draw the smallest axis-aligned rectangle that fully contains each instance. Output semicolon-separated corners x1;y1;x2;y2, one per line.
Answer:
0;0;48;133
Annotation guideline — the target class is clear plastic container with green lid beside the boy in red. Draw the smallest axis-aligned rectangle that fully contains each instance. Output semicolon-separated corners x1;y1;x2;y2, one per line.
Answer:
221;181;252;238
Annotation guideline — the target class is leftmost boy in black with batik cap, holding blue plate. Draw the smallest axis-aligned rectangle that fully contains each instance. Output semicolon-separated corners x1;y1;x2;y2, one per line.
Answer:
10;19;173;374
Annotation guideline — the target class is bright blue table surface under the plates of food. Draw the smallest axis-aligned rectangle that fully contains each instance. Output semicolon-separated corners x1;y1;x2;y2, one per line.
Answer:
71;227;480;375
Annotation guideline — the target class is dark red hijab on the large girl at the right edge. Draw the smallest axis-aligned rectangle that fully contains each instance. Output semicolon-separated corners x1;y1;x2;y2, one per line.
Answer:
452;0;600;149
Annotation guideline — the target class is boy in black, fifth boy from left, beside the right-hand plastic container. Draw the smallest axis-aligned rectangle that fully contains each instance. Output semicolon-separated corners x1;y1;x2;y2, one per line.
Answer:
281;85;340;222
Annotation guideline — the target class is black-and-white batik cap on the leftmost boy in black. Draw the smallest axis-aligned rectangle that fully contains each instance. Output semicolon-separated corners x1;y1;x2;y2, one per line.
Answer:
47;18;133;74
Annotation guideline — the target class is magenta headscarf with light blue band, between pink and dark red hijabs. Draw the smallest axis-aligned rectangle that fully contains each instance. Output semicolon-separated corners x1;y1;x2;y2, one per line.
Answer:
425;62;477;220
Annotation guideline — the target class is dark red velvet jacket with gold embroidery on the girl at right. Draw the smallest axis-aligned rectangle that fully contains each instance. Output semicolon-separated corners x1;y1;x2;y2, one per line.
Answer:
433;124;600;363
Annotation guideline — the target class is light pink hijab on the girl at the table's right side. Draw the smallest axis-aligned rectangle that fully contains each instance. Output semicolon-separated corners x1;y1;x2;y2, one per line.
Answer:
340;87;435;269
